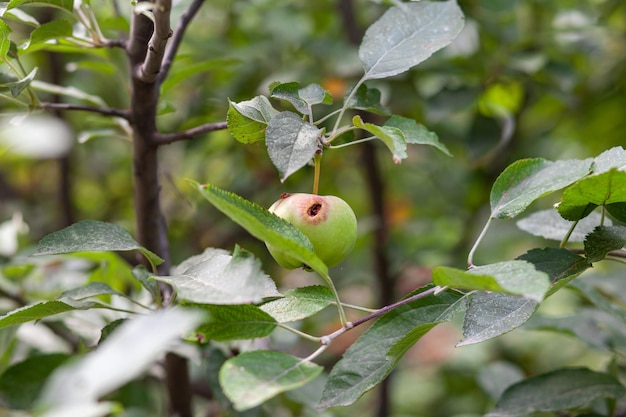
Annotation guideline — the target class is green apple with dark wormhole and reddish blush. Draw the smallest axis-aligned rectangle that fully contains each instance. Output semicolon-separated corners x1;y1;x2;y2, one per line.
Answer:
267;193;357;269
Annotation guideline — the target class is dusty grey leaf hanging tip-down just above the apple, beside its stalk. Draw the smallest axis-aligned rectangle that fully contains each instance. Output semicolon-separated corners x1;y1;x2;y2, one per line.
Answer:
265;112;322;182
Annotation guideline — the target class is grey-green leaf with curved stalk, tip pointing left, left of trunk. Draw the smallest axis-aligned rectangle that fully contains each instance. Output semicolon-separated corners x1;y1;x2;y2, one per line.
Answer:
33;220;163;265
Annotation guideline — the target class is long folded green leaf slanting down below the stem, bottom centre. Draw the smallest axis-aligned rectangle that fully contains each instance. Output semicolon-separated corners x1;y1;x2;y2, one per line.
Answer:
319;287;463;408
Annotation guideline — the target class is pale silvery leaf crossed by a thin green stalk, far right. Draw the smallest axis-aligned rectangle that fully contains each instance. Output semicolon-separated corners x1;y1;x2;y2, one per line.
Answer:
516;209;613;242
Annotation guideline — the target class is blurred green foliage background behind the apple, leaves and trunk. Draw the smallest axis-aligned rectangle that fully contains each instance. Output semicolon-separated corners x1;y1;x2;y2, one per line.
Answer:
0;0;626;417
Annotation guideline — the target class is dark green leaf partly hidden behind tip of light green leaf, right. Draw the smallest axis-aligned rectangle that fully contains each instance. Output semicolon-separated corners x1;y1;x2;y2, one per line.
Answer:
518;248;591;297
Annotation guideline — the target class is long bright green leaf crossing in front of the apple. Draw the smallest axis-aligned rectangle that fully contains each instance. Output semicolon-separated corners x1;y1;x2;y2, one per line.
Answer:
192;181;328;276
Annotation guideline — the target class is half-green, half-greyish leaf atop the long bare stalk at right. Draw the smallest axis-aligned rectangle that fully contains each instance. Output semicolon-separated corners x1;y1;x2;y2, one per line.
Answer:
490;158;592;219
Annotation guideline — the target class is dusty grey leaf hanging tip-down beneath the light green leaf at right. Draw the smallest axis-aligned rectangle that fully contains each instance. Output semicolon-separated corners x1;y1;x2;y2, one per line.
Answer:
457;292;538;346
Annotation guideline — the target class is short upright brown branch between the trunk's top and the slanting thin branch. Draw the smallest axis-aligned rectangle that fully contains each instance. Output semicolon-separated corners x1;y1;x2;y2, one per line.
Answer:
137;0;172;83
